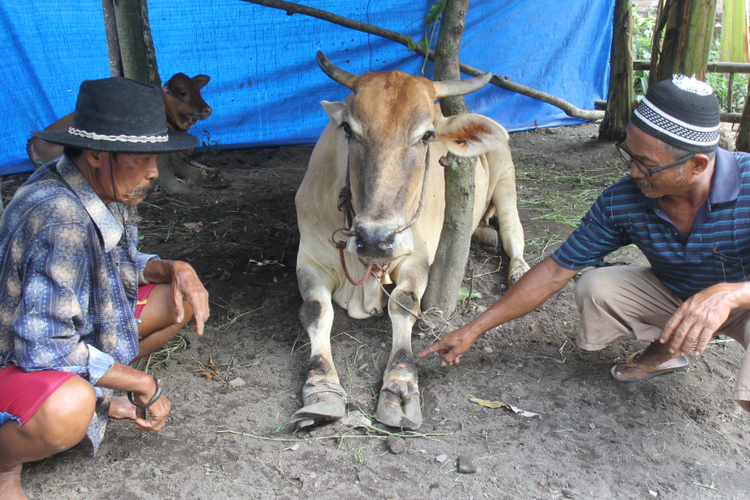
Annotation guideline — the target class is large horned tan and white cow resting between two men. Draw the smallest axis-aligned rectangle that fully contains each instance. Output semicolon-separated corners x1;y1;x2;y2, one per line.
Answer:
293;52;529;429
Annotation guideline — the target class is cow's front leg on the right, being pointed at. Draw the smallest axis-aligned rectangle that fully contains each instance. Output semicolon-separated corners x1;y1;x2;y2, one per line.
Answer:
375;264;429;429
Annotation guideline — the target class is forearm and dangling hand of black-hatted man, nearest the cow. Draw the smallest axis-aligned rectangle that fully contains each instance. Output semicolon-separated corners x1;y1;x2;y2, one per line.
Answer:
143;259;211;335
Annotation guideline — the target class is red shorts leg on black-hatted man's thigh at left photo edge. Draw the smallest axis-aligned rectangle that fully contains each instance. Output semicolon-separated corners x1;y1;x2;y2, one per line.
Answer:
0;365;77;425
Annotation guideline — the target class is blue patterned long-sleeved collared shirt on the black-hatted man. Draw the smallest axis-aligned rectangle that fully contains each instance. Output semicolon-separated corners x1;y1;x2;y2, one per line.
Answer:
0;156;156;452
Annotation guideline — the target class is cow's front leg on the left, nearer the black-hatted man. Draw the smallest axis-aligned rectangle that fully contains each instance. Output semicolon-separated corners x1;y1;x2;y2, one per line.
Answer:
292;262;346;423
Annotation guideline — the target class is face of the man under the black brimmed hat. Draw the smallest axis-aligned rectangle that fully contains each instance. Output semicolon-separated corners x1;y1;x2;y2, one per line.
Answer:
105;153;159;205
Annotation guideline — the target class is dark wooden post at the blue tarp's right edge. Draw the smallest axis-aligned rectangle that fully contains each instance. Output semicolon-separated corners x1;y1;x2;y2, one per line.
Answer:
599;0;634;141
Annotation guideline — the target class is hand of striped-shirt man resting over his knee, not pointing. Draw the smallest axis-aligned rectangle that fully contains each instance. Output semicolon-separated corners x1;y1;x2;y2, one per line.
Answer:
659;283;747;356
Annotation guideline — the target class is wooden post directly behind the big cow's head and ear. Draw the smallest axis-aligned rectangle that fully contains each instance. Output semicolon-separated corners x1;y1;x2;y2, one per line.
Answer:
422;0;476;317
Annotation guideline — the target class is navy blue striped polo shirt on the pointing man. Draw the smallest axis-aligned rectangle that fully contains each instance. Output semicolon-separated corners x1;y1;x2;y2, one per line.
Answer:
552;149;750;299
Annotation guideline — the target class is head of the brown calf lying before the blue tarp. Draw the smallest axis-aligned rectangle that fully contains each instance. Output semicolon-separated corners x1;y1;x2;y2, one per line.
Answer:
162;73;213;132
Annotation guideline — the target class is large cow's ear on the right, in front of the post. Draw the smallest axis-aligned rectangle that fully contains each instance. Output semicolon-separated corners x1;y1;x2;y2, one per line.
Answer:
435;113;510;156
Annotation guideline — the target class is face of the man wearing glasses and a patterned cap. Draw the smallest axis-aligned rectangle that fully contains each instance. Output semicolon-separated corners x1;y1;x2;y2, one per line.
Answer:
625;124;691;198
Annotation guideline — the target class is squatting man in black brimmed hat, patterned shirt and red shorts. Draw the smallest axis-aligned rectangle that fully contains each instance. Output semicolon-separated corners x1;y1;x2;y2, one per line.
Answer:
0;77;209;499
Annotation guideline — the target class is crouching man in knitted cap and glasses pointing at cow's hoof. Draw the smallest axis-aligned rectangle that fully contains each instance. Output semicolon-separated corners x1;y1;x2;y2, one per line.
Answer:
420;75;750;411
